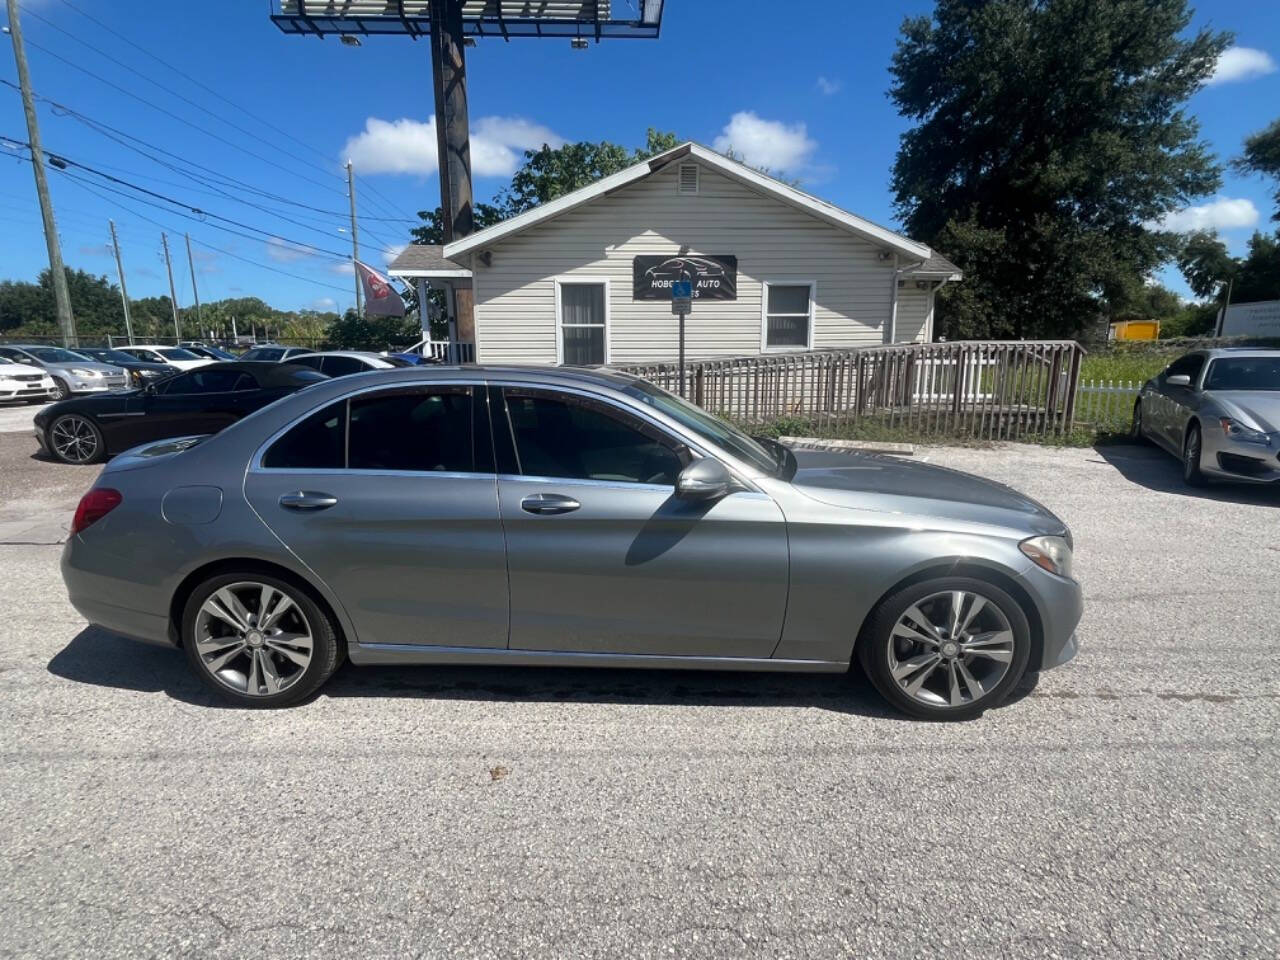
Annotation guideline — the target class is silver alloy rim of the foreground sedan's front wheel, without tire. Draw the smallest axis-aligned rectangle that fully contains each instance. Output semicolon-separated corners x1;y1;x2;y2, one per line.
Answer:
888;590;1015;708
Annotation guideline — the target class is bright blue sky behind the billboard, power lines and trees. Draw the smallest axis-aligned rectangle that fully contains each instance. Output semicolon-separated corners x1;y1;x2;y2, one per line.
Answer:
0;0;1280;316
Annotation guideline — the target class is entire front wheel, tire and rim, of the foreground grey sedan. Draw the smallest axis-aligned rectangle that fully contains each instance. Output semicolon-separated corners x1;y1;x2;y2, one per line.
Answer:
858;577;1032;719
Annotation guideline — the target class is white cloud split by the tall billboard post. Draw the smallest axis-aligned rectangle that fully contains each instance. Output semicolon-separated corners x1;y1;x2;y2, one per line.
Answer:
343;115;564;177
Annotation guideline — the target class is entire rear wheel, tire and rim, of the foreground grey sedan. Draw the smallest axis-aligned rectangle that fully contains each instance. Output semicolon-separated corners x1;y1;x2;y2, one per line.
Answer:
182;572;342;707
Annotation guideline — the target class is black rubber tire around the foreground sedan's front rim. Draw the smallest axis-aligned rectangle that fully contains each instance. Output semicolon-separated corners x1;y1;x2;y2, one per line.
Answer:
858;577;1032;721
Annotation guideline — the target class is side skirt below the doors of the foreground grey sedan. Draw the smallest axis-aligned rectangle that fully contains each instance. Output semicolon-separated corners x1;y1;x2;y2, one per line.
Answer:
347;644;849;673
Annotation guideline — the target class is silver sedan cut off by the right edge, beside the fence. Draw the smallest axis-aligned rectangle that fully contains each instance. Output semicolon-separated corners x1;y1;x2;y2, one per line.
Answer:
1133;347;1280;486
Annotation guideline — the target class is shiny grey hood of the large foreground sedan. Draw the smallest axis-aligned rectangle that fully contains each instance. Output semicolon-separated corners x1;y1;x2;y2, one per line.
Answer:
791;451;1070;538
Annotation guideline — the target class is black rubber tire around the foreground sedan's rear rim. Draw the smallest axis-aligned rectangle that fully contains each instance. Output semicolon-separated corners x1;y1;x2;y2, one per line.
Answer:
182;571;347;709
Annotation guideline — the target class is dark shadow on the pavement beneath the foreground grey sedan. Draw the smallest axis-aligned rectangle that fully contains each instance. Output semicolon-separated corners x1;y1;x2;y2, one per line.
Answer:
49;627;1038;721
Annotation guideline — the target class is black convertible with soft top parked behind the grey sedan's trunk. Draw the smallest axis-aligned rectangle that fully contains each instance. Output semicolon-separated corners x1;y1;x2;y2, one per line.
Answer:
36;361;329;463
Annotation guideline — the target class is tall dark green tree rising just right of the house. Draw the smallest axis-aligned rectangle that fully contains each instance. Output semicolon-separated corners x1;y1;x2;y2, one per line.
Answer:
890;0;1230;338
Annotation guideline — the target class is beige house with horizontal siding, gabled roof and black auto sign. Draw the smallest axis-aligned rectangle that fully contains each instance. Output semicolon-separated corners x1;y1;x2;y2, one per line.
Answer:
389;143;960;365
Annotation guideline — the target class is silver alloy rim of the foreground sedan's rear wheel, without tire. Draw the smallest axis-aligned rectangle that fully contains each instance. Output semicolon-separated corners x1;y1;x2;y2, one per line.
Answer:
195;580;315;696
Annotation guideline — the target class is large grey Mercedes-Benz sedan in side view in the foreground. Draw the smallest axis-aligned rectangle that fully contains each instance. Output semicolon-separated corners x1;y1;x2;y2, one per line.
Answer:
63;366;1082;719
